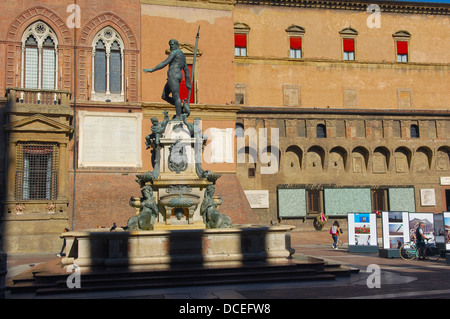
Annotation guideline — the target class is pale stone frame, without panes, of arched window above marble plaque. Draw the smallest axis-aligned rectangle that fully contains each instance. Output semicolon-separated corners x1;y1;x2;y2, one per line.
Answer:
91;26;125;102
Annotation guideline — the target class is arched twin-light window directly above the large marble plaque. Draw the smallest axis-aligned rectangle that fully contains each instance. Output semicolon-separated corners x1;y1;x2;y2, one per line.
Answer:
91;27;124;102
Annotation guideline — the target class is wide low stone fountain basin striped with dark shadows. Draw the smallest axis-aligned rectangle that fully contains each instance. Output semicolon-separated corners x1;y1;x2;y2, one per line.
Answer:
62;225;294;269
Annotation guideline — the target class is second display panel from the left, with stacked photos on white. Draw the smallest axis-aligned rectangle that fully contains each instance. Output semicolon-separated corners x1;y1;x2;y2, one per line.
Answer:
382;212;410;250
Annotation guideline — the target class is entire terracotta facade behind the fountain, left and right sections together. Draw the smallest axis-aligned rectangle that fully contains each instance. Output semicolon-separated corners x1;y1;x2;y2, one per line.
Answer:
0;0;450;252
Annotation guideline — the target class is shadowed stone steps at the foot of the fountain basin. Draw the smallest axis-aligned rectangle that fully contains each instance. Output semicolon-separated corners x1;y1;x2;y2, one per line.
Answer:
9;260;351;295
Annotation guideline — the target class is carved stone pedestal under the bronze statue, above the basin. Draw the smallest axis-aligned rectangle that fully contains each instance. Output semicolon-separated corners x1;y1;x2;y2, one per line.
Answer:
132;120;211;229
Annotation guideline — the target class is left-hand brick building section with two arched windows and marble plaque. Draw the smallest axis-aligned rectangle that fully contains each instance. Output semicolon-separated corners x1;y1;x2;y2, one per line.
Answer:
0;0;252;252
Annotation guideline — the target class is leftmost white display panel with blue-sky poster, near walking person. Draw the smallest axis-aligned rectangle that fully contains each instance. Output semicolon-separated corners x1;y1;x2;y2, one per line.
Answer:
348;213;378;252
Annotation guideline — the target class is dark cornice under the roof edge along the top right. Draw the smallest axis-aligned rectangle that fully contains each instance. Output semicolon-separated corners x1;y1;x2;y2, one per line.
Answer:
236;0;450;15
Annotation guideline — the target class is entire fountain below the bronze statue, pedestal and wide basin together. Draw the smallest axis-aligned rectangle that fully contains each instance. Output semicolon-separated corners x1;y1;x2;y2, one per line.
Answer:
62;112;294;269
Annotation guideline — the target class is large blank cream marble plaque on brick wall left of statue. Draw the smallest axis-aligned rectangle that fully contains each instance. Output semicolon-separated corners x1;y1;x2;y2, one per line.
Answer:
78;111;142;167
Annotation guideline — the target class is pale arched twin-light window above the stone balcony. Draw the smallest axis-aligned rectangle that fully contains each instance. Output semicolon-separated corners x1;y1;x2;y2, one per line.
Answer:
20;21;58;90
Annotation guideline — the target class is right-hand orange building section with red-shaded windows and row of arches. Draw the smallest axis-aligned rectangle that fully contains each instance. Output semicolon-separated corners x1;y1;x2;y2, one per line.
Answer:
233;1;450;226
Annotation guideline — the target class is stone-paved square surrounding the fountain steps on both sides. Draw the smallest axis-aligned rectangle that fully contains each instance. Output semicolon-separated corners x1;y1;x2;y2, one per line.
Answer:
6;231;450;300
